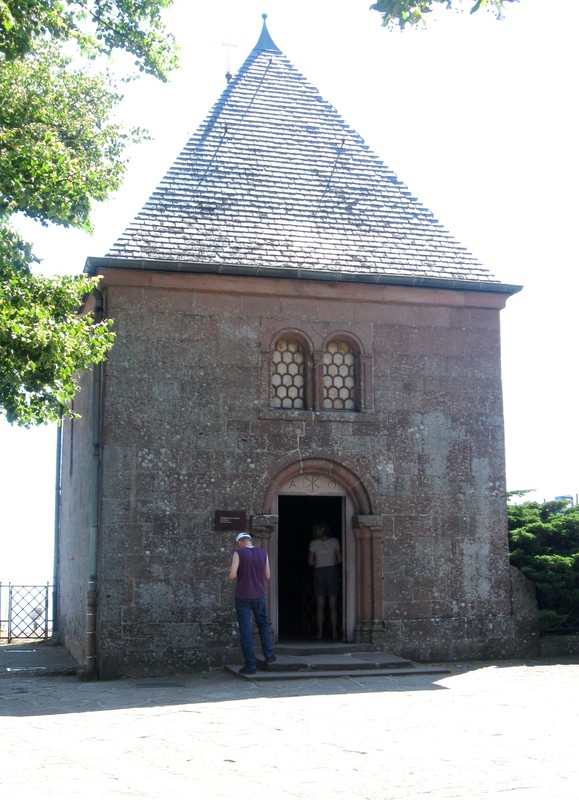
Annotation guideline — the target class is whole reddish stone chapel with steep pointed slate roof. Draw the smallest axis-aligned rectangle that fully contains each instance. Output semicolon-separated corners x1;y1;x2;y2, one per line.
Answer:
57;21;536;678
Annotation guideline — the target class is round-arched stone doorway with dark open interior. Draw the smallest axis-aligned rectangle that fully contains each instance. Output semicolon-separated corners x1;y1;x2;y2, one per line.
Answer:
264;459;371;641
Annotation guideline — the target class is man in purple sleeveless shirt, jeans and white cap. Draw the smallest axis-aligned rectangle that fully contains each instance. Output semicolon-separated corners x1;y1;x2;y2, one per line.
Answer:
229;532;276;675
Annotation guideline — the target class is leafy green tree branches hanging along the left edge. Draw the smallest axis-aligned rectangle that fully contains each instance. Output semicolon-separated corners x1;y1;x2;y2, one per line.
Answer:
0;0;175;426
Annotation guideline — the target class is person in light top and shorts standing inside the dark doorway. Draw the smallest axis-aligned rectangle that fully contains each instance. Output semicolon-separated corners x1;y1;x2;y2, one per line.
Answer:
308;522;342;639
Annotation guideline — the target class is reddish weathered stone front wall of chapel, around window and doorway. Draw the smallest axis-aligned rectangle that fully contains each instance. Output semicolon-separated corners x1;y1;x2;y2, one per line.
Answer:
62;270;536;677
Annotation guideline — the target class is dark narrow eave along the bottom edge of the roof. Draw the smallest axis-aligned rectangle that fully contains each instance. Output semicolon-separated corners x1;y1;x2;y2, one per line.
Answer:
84;256;523;295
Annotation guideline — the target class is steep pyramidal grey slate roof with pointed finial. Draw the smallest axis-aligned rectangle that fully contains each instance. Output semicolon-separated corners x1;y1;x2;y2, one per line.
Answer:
97;15;514;292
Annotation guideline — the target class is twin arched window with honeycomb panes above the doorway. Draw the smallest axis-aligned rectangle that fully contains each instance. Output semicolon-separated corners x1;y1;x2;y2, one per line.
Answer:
271;336;359;411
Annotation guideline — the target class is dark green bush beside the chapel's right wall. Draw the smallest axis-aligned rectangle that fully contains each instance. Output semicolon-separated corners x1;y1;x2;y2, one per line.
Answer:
508;500;579;629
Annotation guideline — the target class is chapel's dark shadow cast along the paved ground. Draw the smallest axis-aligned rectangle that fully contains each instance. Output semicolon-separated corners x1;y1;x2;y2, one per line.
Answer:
0;644;579;717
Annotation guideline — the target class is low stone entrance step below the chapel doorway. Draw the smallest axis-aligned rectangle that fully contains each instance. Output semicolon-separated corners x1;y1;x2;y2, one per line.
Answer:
226;641;448;681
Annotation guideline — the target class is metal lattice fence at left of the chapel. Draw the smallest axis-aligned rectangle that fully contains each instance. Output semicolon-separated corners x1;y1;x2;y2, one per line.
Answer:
0;582;53;642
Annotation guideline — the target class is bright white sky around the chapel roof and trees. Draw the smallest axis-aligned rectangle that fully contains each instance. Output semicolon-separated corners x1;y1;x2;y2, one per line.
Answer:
0;0;579;583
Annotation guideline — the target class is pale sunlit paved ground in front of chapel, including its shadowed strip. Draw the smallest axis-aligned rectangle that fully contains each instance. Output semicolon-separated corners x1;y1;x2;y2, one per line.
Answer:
0;648;579;800
